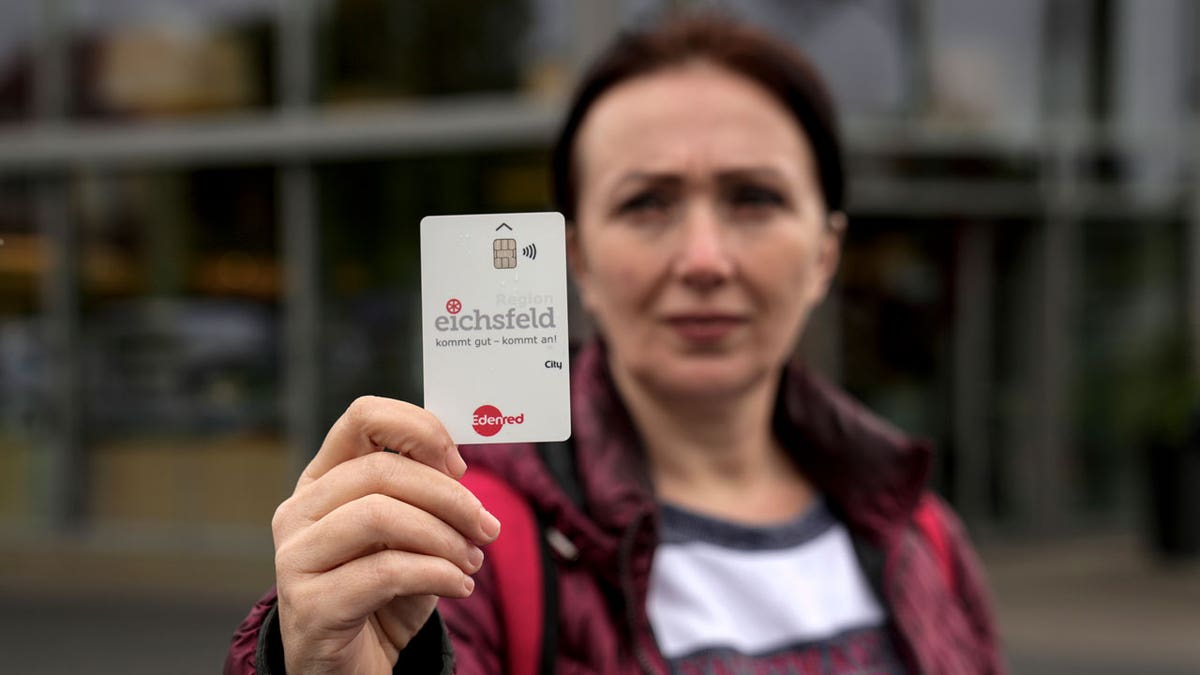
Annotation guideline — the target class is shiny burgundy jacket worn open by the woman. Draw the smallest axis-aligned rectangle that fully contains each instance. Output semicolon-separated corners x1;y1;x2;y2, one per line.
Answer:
226;345;1004;675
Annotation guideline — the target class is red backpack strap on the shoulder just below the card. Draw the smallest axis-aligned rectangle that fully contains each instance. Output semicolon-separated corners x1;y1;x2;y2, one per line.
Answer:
462;468;544;675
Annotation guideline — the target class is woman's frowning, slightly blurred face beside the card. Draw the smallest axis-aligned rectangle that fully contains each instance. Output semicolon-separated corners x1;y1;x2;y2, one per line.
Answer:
569;62;841;398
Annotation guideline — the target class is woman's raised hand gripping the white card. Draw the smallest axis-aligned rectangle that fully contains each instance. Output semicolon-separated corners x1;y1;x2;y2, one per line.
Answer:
271;396;500;674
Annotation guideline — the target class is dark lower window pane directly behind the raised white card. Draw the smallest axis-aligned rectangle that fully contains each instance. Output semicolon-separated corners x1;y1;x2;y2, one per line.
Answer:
319;151;550;424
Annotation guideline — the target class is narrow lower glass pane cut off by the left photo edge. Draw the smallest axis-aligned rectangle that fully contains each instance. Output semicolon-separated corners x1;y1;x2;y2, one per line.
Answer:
0;180;47;522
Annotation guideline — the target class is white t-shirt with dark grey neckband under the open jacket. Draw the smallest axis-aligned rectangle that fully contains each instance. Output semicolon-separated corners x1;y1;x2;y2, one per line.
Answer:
648;502;904;675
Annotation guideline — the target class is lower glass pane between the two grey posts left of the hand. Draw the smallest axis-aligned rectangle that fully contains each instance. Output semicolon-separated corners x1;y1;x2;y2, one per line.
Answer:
73;168;287;528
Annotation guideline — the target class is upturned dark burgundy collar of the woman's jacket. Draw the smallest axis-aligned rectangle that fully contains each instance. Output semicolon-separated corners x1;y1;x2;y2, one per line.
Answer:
468;341;932;549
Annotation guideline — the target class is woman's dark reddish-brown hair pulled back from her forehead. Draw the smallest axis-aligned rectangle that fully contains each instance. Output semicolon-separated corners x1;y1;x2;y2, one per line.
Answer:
552;14;845;221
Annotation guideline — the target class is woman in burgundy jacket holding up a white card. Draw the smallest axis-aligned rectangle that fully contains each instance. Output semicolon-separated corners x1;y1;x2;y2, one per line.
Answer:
227;11;1002;674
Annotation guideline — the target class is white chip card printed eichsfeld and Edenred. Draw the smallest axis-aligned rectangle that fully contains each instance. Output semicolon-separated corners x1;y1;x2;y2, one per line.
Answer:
421;213;571;443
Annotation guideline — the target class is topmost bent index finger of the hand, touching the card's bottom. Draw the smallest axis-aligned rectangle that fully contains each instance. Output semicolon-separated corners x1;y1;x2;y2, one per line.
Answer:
296;396;467;486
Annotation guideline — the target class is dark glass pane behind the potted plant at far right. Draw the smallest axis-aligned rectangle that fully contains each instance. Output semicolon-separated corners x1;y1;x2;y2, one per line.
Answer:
1073;216;1185;514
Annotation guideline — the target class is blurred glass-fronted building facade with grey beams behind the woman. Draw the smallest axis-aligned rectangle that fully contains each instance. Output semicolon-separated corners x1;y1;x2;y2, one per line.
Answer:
0;0;1200;564
